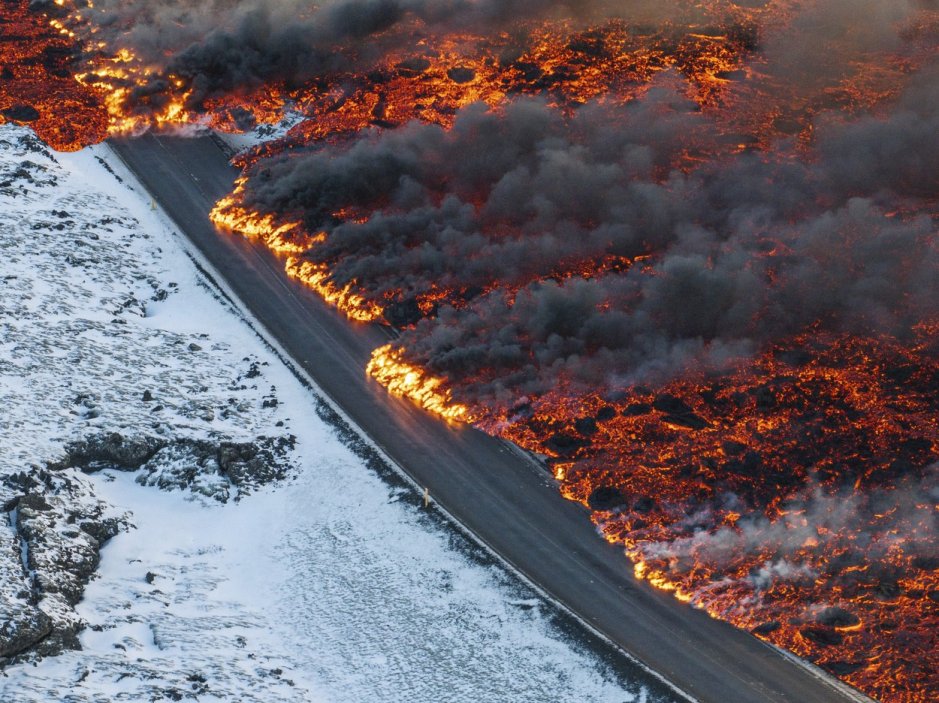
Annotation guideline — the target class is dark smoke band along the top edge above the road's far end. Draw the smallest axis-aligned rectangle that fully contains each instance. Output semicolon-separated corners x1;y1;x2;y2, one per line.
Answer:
71;0;651;112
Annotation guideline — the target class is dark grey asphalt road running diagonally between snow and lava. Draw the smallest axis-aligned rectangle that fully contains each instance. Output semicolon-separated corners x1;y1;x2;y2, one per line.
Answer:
112;135;857;703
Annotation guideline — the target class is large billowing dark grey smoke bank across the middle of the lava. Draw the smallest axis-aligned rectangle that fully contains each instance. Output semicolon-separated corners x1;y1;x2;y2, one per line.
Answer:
237;57;939;402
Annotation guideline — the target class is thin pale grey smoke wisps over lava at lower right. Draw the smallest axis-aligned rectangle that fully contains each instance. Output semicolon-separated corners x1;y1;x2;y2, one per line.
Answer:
638;466;939;610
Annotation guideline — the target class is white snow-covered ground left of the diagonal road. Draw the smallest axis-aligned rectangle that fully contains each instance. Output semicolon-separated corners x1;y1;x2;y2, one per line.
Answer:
0;126;668;703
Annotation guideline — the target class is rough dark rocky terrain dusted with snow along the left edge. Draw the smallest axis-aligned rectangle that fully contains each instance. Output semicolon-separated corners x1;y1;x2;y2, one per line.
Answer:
0;127;302;667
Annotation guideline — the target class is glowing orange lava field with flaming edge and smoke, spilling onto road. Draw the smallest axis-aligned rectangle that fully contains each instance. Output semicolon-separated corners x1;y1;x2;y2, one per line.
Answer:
0;0;939;703
